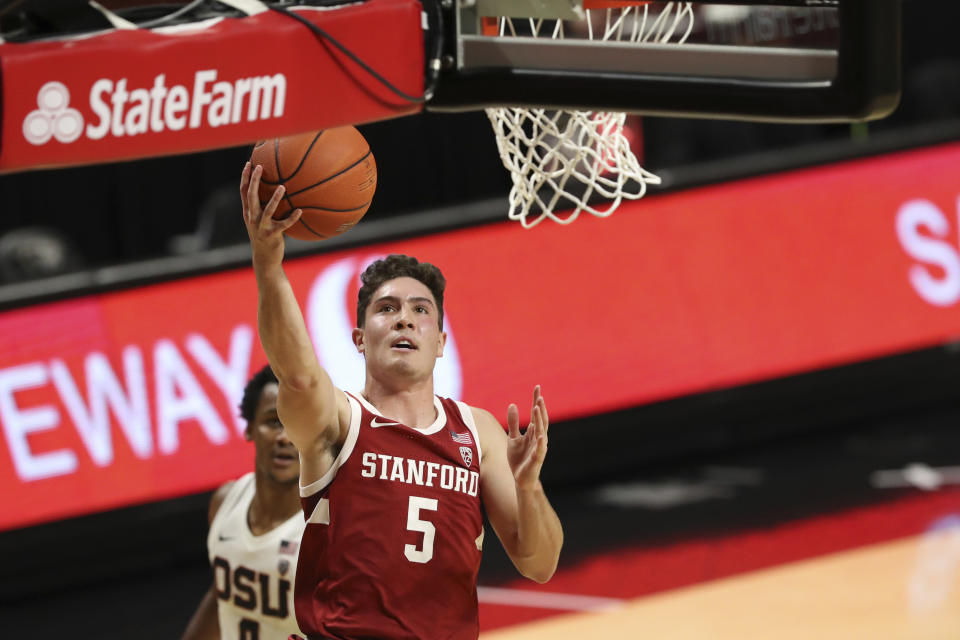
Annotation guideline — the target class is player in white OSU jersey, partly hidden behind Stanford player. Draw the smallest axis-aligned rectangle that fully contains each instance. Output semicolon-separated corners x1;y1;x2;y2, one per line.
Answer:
183;367;304;640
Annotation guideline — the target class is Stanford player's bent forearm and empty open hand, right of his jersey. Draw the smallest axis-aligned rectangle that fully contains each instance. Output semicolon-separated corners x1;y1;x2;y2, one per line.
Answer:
474;386;563;582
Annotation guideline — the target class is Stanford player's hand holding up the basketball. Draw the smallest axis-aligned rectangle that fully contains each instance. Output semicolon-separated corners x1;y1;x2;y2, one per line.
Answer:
240;162;303;264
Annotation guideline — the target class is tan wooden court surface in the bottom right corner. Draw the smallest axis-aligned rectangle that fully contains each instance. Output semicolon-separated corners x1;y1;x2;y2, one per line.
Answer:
481;527;960;640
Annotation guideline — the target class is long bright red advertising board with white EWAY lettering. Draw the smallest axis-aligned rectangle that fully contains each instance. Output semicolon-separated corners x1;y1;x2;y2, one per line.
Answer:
0;144;960;528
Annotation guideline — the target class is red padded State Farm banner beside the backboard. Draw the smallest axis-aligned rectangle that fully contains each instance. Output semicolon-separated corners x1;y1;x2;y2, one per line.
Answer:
0;0;424;171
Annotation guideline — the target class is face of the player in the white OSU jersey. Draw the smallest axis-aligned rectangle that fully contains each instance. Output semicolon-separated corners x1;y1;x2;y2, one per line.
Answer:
247;383;300;484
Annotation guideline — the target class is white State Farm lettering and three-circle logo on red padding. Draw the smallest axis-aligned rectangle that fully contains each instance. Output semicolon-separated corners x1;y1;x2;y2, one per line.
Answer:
23;69;287;145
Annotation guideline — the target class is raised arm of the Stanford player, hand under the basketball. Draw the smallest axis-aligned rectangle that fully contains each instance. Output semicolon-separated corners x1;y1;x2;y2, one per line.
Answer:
240;162;349;460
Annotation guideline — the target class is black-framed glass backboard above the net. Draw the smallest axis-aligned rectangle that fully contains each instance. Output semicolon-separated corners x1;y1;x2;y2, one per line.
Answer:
428;0;900;122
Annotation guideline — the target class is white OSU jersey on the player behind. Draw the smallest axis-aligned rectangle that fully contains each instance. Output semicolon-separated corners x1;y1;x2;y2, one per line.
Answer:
207;472;304;640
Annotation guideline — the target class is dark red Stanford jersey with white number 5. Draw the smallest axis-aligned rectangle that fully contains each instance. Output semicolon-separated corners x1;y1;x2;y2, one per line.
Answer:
294;394;483;640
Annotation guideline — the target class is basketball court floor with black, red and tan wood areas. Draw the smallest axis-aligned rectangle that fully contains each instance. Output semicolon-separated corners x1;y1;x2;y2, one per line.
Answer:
472;416;960;640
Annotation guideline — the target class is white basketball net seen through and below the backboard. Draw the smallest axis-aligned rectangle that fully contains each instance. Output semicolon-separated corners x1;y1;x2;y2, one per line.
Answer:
486;0;693;229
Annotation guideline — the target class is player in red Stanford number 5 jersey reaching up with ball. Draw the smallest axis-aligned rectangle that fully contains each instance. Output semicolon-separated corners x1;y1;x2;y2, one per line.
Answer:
240;163;563;640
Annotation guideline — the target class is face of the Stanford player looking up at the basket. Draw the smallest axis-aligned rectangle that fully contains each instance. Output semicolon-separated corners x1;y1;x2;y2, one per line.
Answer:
354;277;447;381
